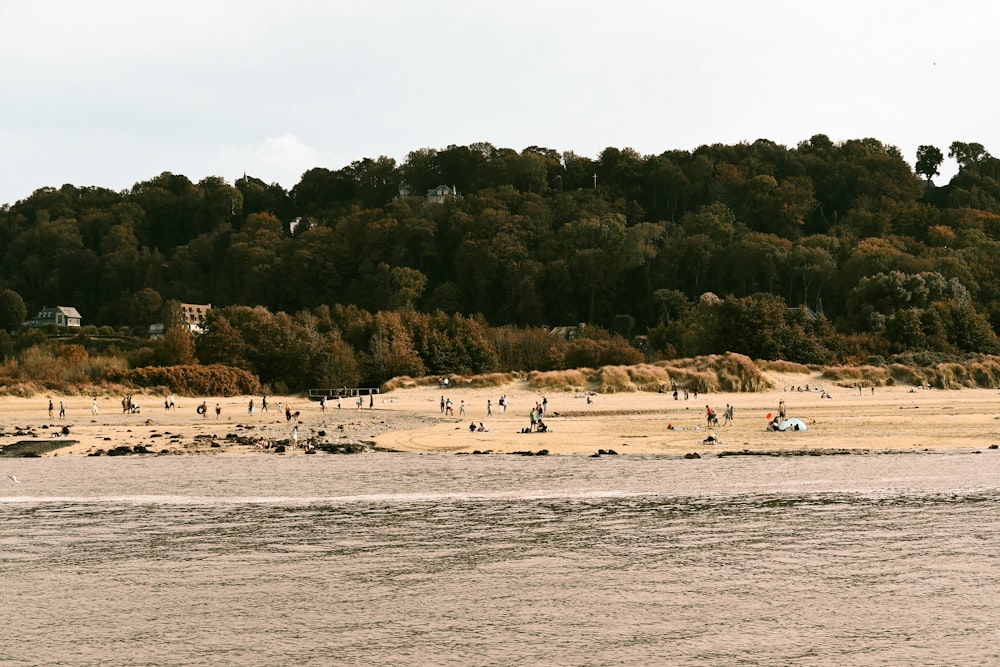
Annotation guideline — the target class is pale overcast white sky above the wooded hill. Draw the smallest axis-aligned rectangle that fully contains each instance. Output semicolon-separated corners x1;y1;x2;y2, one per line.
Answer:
0;0;1000;204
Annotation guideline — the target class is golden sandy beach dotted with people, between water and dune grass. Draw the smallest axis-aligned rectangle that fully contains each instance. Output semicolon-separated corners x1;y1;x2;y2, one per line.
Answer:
0;373;1000;456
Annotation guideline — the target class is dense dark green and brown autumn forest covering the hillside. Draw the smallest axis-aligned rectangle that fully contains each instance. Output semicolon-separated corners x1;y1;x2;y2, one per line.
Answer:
0;135;1000;388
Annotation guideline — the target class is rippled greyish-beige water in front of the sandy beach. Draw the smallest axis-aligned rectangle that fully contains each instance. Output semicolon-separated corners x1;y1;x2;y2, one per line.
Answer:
0;451;1000;665
